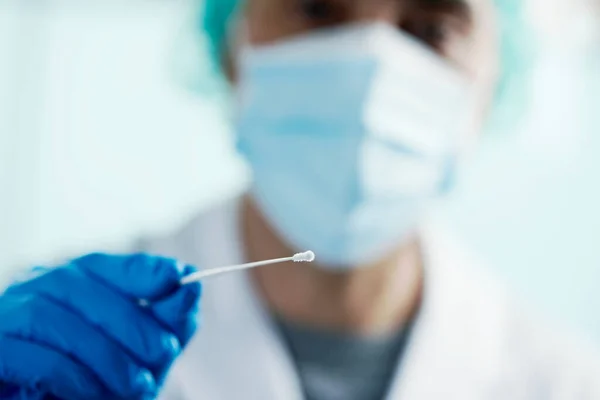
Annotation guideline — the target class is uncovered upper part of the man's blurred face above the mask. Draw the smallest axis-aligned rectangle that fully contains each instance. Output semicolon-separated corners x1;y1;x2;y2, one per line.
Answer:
232;0;498;134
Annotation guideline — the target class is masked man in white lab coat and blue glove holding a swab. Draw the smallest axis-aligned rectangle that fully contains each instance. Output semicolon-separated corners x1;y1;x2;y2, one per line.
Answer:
0;0;600;400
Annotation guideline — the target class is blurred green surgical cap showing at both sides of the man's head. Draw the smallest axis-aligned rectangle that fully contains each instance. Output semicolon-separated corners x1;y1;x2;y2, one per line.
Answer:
200;0;533;128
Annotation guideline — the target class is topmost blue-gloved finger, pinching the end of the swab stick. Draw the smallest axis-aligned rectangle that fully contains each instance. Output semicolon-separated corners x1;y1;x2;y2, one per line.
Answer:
73;254;183;300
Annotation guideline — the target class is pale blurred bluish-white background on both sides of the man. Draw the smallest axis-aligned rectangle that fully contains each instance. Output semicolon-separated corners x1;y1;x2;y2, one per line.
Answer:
0;0;600;344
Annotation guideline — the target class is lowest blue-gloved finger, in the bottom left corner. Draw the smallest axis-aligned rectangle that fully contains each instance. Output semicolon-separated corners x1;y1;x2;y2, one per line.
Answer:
0;335;109;400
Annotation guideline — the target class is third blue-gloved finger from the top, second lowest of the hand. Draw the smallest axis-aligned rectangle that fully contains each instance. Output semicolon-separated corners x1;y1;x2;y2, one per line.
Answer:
0;294;156;398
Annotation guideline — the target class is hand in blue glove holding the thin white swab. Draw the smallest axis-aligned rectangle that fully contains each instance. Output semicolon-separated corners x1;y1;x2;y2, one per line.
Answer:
0;254;201;400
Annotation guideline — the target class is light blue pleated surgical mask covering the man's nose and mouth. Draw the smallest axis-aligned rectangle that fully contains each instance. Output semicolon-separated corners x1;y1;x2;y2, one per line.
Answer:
237;24;471;270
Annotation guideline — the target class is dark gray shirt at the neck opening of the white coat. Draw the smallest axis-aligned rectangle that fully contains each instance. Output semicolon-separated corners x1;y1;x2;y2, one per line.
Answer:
275;319;408;400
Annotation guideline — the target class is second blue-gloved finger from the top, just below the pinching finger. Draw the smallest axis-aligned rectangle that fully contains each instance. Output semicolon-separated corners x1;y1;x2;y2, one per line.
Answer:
6;266;181;369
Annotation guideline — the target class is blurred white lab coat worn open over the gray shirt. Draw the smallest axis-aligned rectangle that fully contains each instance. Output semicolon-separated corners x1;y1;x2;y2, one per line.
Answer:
138;201;600;400
